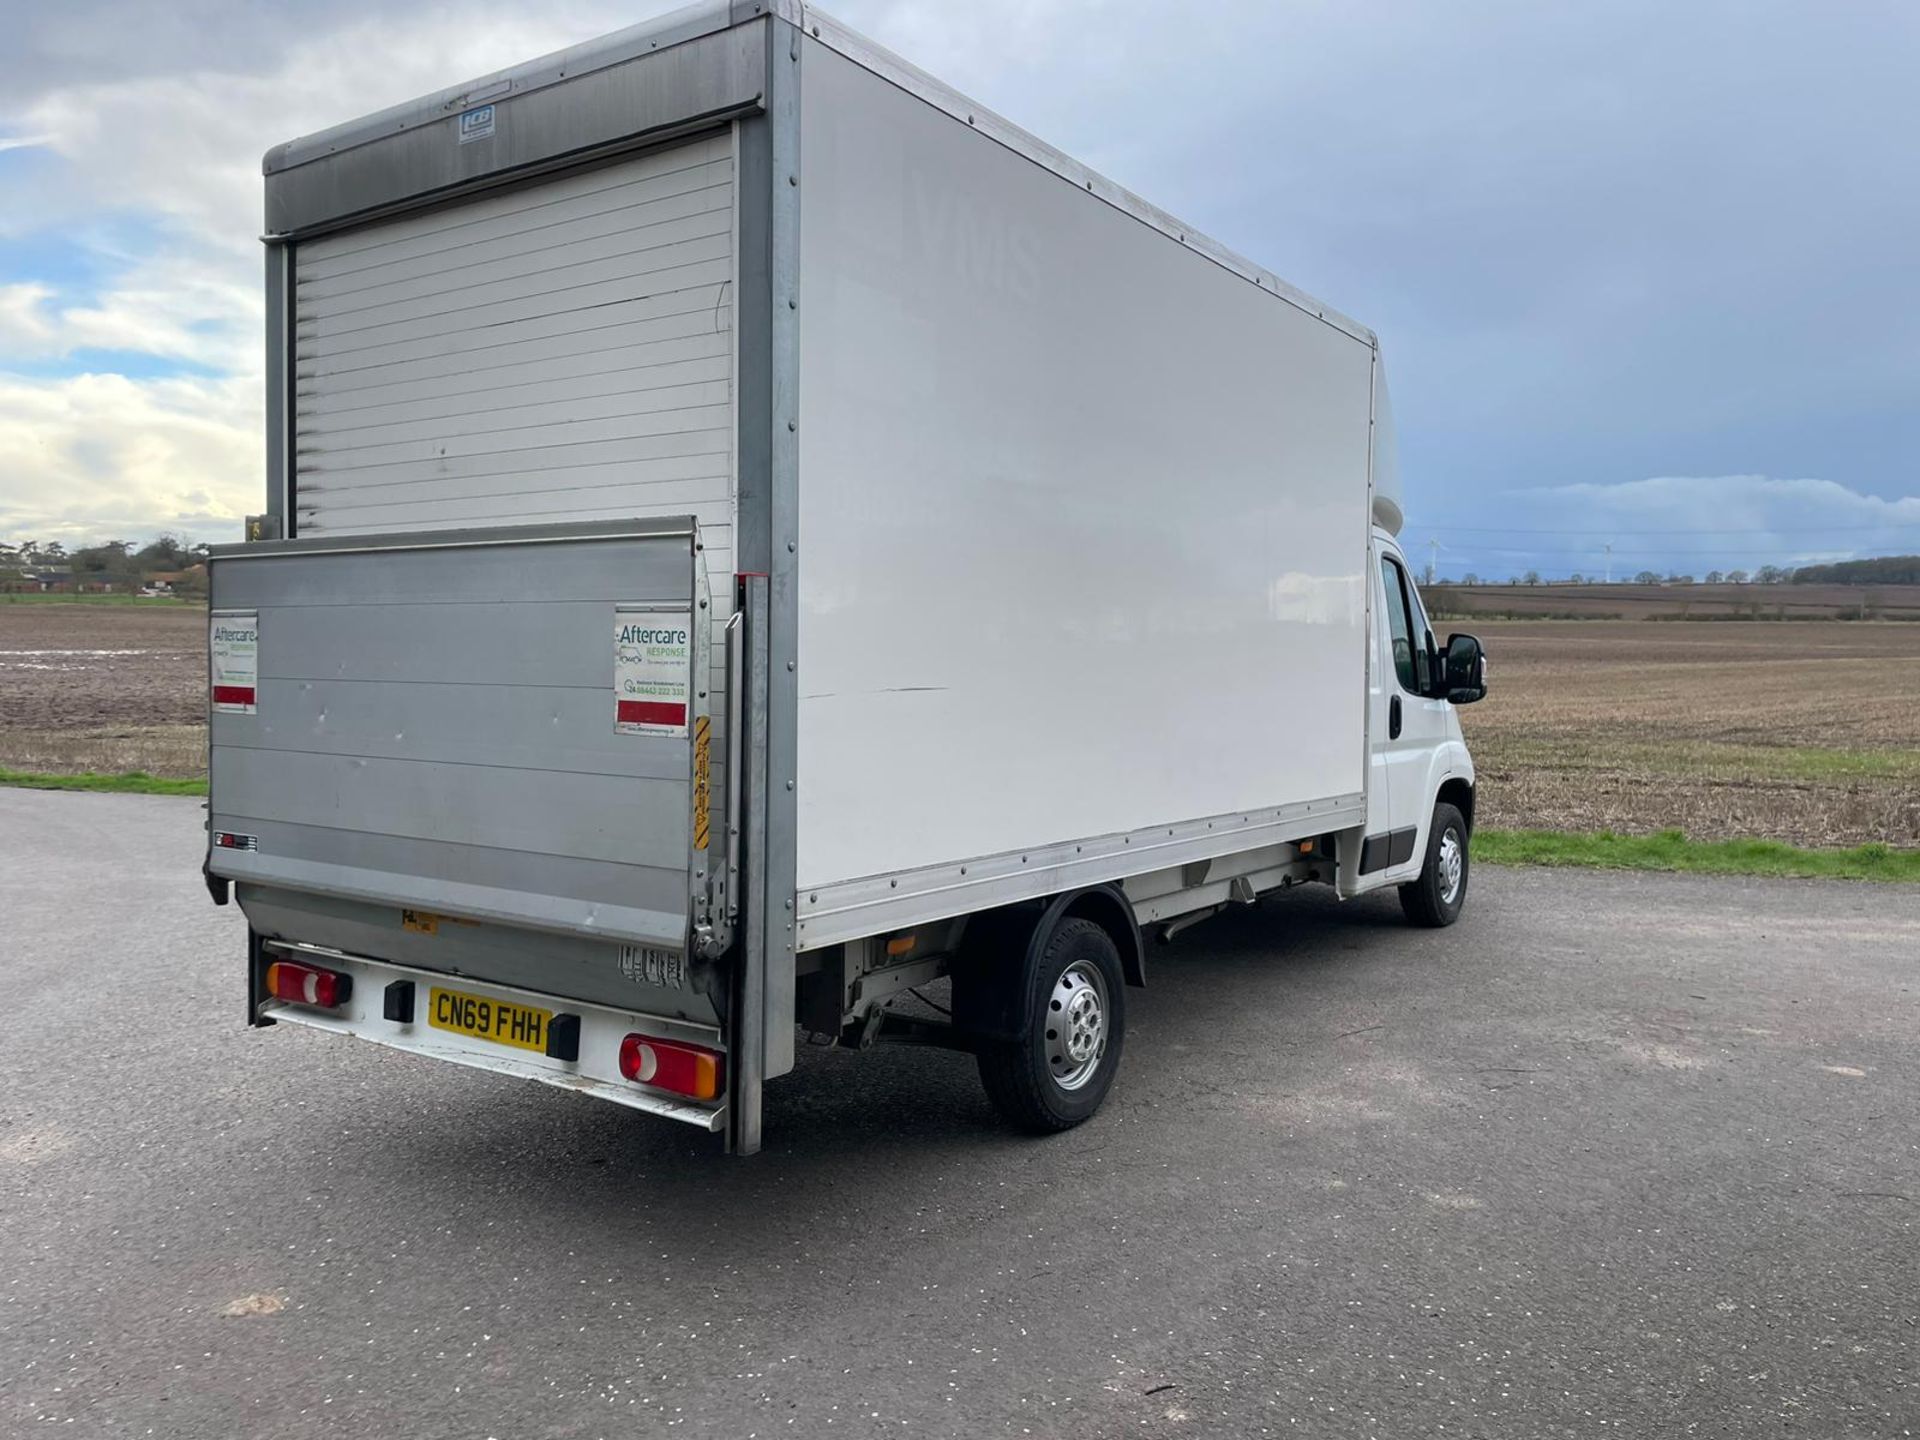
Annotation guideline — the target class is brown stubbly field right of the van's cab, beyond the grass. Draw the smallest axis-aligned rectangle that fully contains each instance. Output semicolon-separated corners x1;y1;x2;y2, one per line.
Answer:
1459;620;1920;845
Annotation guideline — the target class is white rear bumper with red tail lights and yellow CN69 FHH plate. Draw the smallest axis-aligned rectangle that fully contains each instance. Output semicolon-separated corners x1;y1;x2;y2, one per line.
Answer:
253;941;728;1133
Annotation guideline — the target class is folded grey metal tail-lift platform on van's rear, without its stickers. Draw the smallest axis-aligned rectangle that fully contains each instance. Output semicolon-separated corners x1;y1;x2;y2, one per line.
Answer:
209;528;701;952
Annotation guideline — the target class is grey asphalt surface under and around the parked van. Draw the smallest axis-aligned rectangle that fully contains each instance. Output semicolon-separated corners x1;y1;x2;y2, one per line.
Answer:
0;791;1920;1440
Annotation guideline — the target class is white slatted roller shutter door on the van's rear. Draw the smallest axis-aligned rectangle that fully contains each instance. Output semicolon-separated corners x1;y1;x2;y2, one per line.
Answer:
294;134;733;587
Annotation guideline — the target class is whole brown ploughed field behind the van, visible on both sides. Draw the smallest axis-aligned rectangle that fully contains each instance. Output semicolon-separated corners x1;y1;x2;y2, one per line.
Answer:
0;603;1920;845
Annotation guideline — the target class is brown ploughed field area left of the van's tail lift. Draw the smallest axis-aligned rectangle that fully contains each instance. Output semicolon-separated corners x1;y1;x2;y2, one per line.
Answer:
0;599;207;776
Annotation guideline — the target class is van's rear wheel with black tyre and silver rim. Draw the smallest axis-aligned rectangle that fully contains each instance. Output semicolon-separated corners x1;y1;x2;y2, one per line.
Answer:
979;920;1127;1135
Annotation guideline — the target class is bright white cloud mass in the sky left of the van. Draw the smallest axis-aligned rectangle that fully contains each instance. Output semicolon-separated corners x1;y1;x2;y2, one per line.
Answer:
0;6;645;545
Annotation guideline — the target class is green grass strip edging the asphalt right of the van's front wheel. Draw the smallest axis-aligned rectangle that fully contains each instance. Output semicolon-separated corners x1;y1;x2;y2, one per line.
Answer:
1473;829;1920;883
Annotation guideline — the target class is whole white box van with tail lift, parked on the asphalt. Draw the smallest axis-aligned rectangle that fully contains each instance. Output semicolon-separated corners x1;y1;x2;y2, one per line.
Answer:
205;0;1484;1152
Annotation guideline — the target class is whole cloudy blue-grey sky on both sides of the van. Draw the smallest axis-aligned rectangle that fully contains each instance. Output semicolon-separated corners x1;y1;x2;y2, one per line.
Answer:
0;0;1920;576
